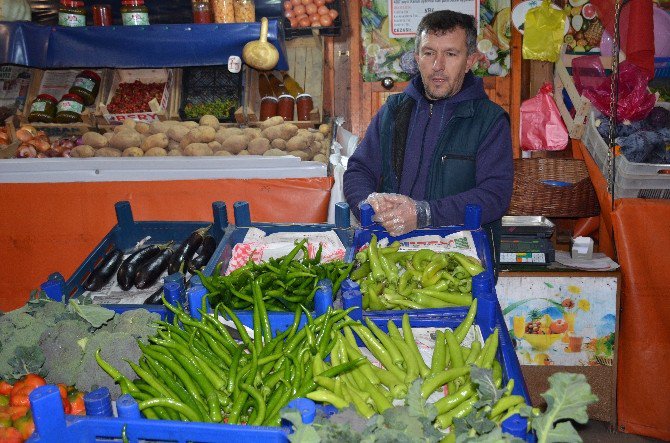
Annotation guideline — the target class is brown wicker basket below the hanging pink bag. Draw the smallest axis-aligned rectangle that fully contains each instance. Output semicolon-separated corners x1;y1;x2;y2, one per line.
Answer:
507;158;600;217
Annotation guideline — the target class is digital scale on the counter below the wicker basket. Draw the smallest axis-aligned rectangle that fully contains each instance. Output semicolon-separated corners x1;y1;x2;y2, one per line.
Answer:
499;215;556;266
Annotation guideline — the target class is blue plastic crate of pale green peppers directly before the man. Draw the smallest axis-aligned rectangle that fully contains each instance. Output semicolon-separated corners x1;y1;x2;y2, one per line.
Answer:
345;204;495;315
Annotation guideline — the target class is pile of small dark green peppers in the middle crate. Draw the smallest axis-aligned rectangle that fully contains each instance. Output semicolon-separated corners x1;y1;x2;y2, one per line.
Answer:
199;239;354;312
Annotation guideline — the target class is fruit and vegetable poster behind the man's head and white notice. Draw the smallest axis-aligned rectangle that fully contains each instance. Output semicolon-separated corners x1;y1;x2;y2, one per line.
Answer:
361;0;511;82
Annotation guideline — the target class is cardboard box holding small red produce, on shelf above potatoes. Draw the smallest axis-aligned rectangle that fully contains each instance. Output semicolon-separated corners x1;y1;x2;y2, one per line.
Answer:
98;69;177;124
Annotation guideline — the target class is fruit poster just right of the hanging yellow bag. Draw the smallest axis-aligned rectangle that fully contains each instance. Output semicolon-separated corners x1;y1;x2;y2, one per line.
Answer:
563;0;603;54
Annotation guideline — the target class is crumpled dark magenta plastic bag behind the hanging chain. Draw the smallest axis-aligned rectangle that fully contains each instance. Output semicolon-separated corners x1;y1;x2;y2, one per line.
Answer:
572;56;656;123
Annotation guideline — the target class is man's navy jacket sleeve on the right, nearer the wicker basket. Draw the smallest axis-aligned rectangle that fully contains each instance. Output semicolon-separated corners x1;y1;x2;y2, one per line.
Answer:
429;116;514;226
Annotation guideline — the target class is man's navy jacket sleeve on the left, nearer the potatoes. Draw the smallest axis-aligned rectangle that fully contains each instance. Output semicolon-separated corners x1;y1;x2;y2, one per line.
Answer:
343;108;384;220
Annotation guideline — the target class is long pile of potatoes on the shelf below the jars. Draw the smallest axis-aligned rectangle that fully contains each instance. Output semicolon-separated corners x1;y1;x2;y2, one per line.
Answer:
71;115;330;163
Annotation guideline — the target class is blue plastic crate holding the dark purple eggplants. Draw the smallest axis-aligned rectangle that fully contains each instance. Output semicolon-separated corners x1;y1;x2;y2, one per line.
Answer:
41;201;232;316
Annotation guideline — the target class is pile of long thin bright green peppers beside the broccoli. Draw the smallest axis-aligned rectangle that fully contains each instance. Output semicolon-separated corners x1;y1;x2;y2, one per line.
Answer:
96;292;365;426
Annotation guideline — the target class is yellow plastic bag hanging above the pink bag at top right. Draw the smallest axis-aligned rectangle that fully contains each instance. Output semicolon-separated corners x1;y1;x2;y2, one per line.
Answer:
523;0;566;62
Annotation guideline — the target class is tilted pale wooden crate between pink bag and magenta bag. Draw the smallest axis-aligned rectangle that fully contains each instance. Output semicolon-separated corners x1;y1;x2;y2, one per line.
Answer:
554;46;625;139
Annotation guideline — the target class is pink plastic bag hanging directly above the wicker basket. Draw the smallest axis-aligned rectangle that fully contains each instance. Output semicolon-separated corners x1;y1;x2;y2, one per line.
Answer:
519;83;568;151
